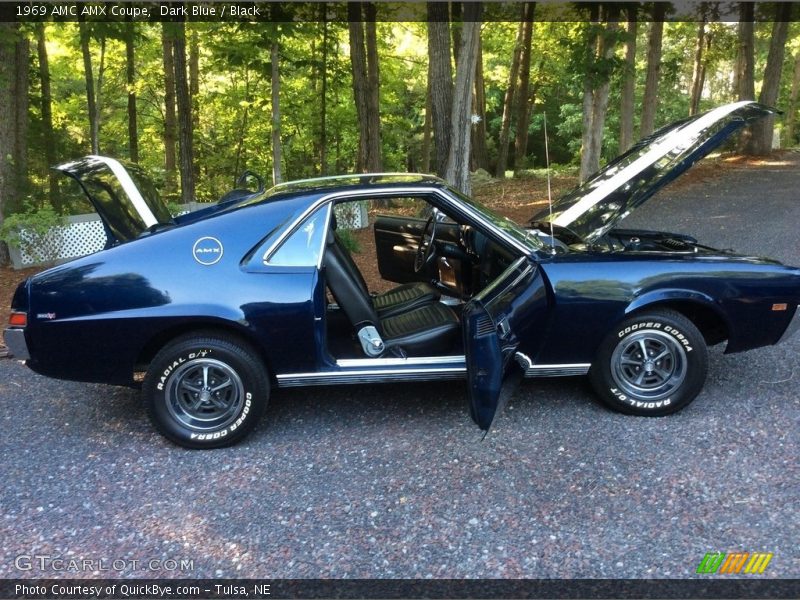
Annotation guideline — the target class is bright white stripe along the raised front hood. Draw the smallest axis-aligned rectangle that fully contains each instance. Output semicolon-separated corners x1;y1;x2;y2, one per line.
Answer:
553;100;752;227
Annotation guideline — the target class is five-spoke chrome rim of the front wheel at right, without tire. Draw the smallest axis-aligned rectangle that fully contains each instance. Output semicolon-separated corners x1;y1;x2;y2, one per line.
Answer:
611;330;688;402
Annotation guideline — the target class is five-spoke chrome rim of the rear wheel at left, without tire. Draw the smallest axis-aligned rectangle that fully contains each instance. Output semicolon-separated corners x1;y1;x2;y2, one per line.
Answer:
165;358;244;431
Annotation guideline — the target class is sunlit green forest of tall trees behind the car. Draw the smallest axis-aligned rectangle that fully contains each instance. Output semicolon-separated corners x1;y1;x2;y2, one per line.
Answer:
0;2;800;262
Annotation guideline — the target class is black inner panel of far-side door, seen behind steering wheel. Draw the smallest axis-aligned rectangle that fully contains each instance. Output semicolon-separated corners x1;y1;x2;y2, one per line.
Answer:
375;215;466;291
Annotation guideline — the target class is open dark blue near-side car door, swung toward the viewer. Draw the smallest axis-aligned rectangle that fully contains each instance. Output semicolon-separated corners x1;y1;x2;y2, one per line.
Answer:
463;257;547;431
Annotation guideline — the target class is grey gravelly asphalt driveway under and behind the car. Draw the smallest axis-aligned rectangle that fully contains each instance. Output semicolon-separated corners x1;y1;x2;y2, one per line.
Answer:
0;155;800;578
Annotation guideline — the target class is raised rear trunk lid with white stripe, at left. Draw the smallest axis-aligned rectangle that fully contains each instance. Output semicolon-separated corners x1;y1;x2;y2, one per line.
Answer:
54;156;173;246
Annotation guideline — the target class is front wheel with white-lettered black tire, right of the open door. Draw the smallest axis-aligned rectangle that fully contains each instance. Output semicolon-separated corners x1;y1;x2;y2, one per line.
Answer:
589;309;708;417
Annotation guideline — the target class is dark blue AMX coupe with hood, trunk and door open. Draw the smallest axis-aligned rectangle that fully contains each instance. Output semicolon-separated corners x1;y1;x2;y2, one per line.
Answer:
5;102;800;448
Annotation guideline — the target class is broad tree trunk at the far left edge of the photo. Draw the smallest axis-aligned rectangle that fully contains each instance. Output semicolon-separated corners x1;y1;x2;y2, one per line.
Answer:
0;23;30;264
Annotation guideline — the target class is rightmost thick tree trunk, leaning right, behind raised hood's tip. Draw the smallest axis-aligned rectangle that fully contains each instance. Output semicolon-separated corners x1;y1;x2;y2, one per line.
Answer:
747;2;792;156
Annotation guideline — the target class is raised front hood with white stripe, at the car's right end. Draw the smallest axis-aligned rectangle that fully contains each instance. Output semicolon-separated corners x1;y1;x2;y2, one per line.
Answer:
530;101;777;243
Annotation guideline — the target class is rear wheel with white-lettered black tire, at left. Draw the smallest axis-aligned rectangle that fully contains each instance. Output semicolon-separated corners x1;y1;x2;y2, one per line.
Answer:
142;334;269;448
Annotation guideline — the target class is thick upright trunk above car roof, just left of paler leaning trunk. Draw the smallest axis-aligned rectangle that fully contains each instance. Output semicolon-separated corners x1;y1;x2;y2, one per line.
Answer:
428;2;453;176
